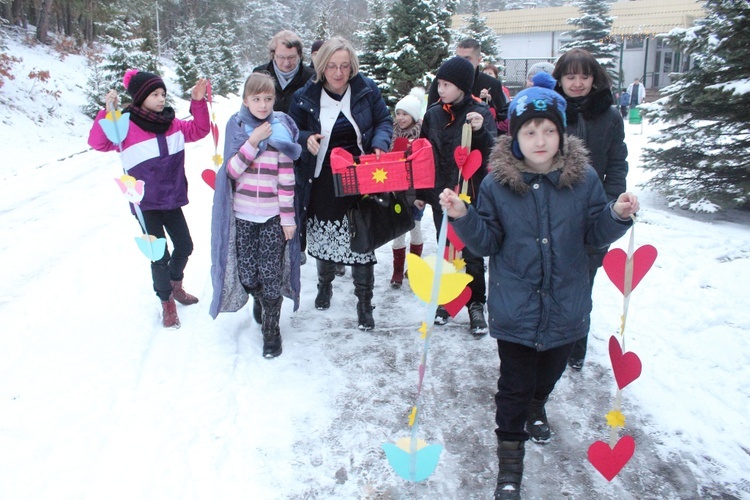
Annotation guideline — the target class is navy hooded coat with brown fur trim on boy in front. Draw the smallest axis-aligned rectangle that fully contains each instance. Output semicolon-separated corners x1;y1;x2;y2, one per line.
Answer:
452;136;632;351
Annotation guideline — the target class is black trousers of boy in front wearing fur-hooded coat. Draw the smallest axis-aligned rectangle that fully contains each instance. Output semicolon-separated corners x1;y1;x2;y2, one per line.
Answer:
495;340;573;441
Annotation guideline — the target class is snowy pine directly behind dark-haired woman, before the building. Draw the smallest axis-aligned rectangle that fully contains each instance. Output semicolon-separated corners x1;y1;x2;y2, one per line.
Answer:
560;0;618;81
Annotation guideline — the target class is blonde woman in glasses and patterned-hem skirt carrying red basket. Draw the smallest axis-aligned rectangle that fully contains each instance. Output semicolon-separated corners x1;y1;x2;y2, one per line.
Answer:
289;37;393;330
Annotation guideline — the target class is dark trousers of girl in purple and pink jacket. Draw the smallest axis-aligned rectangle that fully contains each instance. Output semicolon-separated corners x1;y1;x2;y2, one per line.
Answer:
143;208;193;300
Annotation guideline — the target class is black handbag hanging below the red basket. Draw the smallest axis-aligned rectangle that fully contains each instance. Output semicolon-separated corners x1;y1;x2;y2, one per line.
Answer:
346;191;414;253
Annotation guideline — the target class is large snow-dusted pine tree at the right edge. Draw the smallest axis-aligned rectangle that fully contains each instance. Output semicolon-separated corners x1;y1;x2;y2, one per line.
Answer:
643;0;750;211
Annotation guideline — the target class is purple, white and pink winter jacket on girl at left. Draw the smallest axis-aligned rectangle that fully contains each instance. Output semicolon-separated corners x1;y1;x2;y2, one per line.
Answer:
88;100;210;210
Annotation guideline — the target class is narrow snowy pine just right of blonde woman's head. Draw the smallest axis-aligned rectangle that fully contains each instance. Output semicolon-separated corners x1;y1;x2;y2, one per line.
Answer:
357;0;390;95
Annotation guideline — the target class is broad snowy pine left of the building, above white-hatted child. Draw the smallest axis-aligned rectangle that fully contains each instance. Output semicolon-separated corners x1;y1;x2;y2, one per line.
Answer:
385;0;455;105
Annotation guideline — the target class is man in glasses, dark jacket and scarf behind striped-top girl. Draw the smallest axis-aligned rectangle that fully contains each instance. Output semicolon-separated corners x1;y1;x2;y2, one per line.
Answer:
253;30;315;113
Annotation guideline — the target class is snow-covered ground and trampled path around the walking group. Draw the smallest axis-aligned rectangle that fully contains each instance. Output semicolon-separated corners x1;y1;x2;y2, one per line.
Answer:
0;33;750;499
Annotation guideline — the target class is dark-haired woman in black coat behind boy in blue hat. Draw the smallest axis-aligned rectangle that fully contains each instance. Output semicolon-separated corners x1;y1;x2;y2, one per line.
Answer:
552;49;628;370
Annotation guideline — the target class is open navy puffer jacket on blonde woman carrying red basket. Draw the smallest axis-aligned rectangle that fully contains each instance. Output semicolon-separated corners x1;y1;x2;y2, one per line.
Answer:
289;74;393;220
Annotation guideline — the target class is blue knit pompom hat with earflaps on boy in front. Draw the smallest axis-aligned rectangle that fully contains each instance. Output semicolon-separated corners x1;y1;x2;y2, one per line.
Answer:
508;72;567;160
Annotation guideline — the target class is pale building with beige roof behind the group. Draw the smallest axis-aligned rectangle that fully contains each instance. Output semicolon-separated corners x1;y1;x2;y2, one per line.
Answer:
453;0;706;94
